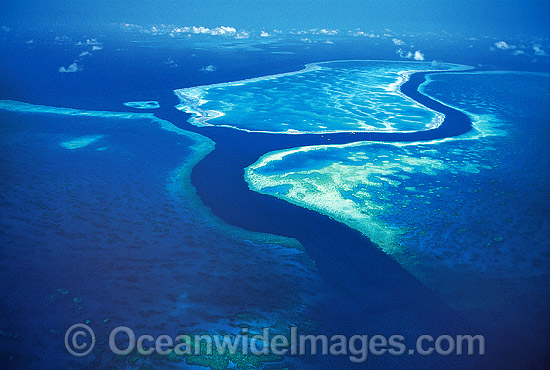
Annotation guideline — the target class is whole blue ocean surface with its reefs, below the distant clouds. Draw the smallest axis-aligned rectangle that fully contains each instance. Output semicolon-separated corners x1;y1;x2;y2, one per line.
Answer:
0;25;550;370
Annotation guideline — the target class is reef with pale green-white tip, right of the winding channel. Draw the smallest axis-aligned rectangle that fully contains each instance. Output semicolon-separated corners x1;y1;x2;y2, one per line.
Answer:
246;73;550;313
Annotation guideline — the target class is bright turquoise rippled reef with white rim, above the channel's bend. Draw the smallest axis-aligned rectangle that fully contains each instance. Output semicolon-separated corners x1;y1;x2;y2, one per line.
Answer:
177;61;467;133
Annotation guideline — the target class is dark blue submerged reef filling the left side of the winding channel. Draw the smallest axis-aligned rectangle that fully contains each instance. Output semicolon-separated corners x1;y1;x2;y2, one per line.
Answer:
0;101;318;369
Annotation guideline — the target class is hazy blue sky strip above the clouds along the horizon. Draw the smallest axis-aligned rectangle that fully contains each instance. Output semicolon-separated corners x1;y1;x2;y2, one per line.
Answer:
0;0;550;36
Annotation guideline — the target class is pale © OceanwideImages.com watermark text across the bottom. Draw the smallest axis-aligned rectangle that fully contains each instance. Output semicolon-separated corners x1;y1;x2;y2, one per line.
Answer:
65;324;485;363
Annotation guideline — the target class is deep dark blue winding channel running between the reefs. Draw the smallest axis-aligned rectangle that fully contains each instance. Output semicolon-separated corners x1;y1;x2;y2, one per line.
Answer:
150;62;548;368
